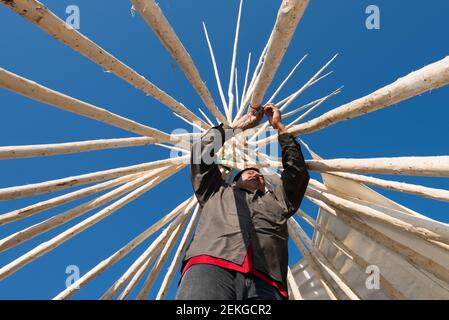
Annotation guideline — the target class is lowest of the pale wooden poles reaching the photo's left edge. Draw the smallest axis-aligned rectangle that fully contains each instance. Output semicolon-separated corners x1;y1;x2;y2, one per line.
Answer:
0;165;182;279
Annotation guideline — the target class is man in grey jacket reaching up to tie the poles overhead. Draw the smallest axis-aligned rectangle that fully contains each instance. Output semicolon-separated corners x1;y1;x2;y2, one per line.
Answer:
176;104;310;300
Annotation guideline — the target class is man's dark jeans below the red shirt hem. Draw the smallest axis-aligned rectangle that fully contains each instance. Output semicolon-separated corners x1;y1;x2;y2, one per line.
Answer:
175;264;285;300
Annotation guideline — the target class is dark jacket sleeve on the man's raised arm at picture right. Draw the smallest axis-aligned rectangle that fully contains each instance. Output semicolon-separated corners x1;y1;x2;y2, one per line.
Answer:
278;133;310;217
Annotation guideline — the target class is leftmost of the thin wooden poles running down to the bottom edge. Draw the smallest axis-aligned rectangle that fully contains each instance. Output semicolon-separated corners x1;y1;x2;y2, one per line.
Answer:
53;198;192;300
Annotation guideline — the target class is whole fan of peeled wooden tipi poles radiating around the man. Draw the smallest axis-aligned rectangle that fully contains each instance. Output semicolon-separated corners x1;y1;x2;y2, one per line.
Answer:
0;0;449;299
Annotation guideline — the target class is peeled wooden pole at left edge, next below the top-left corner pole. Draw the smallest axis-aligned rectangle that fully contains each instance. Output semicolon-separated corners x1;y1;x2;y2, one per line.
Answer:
0;68;171;142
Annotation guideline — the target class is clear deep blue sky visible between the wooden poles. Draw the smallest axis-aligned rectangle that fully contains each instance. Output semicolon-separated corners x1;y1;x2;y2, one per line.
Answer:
0;0;449;299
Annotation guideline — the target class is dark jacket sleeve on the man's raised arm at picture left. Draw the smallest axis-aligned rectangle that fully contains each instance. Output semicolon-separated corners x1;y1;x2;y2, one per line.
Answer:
190;124;234;207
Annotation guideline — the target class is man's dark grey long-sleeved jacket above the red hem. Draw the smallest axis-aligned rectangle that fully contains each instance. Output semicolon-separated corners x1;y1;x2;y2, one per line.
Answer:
184;124;310;290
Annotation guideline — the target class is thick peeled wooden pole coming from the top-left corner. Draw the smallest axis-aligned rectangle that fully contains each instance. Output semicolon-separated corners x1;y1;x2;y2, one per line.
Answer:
0;0;207;126
